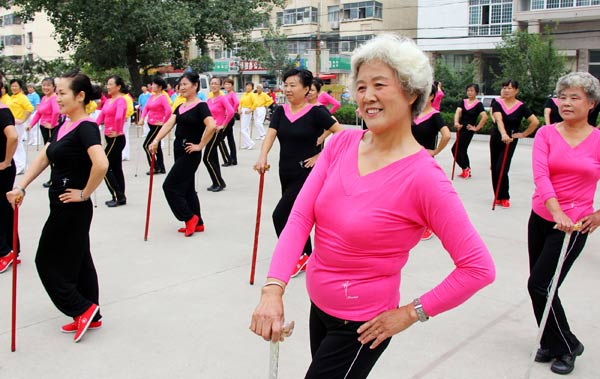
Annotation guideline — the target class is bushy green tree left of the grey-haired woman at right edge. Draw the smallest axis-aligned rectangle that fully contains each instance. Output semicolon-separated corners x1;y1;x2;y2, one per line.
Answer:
496;30;567;114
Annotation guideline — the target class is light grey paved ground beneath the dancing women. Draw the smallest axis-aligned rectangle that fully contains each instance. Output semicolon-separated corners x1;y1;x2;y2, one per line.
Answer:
0;125;600;379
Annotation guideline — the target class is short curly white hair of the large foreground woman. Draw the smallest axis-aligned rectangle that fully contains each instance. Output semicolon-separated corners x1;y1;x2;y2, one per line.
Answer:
351;33;433;118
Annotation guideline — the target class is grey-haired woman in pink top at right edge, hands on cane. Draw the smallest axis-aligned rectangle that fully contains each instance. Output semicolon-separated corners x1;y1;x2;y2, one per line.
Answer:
527;72;600;374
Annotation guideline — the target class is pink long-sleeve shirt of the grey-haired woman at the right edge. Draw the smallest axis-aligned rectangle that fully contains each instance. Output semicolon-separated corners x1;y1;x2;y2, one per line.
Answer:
532;124;600;222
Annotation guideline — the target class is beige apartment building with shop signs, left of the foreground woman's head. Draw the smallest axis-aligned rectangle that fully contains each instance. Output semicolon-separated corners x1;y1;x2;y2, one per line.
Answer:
202;0;417;85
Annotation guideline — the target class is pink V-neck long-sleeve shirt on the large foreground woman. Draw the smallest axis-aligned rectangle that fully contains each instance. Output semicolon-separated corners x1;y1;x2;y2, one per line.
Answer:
268;130;495;321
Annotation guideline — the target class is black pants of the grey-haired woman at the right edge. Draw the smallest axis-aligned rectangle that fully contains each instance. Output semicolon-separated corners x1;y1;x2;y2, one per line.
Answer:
527;211;588;356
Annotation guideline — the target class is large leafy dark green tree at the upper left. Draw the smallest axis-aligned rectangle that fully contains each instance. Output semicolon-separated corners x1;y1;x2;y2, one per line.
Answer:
13;0;282;93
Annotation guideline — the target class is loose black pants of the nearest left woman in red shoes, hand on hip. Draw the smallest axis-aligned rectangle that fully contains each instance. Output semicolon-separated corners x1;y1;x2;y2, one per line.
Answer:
35;200;102;321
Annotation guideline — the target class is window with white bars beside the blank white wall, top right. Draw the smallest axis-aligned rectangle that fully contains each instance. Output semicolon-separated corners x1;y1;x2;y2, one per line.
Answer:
469;0;512;36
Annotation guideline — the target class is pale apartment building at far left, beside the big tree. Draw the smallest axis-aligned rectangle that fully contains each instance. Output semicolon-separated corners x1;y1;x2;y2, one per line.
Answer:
0;7;61;61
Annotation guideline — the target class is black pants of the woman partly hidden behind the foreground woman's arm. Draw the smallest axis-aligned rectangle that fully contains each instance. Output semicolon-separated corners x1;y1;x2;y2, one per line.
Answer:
273;169;312;255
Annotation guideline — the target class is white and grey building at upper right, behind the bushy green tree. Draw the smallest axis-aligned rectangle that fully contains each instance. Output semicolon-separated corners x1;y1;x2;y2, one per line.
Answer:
417;0;600;94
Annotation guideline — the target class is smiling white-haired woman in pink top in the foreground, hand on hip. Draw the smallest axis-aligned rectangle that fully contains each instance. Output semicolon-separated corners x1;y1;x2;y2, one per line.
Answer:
250;34;495;379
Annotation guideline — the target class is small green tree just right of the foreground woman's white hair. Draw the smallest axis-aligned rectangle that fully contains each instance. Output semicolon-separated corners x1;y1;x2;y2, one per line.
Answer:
434;59;478;114
